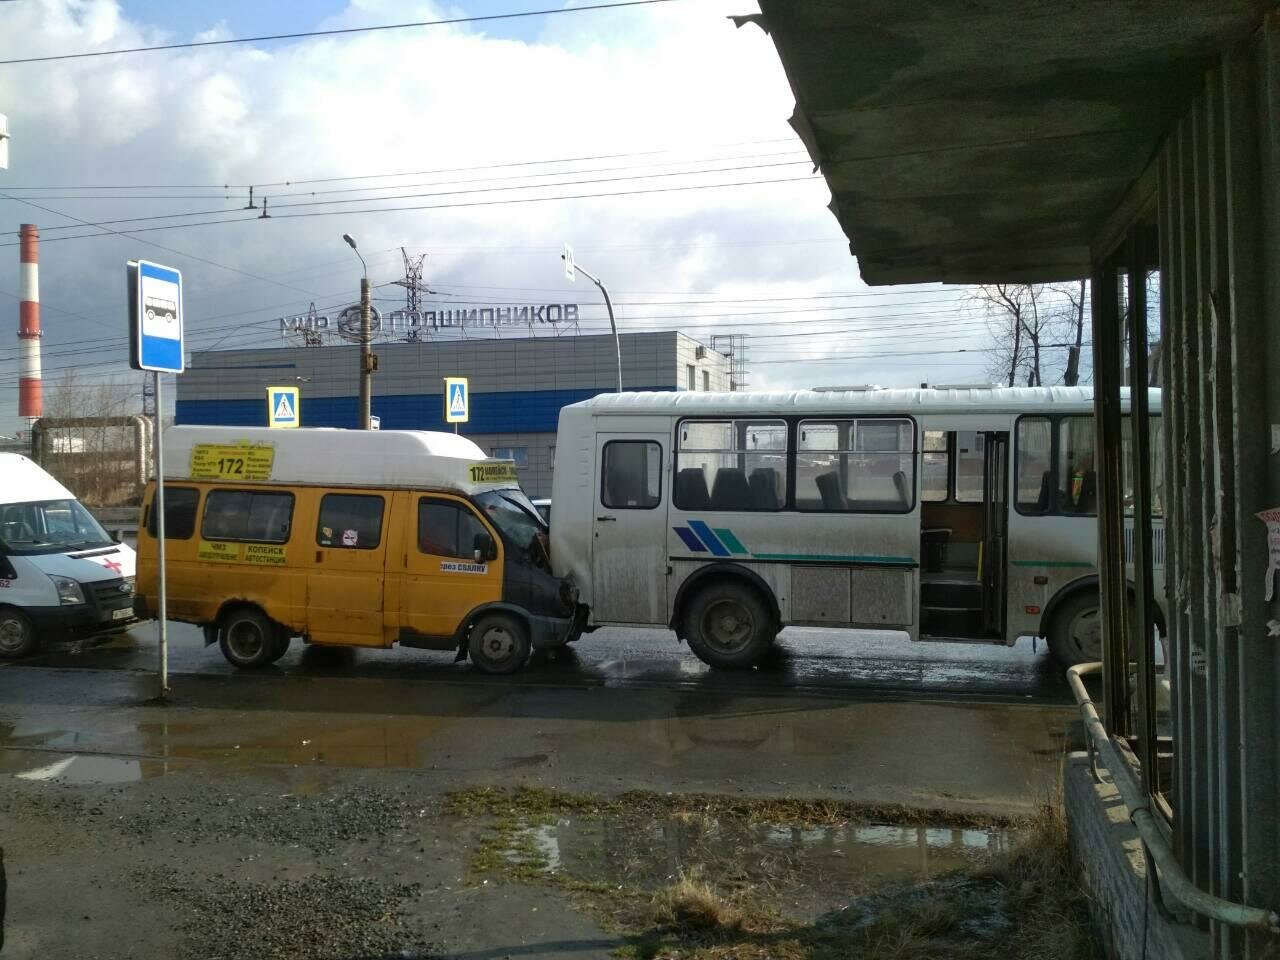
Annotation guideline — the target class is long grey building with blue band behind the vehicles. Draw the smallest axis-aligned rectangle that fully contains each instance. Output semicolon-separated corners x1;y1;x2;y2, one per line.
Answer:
174;332;732;497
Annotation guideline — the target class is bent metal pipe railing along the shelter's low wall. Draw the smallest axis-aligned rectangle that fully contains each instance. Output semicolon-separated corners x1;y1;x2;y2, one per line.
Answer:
1066;663;1280;934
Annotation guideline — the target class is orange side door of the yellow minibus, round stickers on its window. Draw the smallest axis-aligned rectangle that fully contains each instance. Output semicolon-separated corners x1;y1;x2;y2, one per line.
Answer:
309;492;390;646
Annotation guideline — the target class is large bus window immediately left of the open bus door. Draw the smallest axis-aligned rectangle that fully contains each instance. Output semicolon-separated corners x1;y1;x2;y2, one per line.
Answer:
796;419;915;513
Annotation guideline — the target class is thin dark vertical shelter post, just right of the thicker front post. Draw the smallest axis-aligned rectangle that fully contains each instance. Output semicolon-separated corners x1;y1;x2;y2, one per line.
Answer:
1126;235;1160;796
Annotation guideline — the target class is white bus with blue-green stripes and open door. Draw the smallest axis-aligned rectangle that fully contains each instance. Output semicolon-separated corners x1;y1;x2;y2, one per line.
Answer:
552;387;1164;667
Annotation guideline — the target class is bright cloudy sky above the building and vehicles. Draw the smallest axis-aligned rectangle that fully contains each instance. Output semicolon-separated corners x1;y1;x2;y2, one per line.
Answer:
0;0;987;433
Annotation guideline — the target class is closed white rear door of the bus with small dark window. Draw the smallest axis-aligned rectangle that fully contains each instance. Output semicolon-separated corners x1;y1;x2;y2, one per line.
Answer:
591;433;669;625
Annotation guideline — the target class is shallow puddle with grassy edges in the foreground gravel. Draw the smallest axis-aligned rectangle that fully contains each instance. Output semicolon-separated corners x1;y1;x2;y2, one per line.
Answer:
488;814;1012;911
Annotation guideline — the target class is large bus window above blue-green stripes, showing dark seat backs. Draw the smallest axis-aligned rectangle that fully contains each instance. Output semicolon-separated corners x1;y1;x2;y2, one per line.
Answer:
675;420;787;511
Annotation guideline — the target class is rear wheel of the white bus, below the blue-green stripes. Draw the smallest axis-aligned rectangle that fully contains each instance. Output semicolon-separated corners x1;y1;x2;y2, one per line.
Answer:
685;581;778;669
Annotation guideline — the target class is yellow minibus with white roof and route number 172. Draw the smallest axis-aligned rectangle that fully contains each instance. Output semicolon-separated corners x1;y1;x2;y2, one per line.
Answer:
136;426;581;673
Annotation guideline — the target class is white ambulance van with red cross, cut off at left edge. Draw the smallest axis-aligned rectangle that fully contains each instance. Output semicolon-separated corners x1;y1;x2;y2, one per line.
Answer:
0;453;134;659
